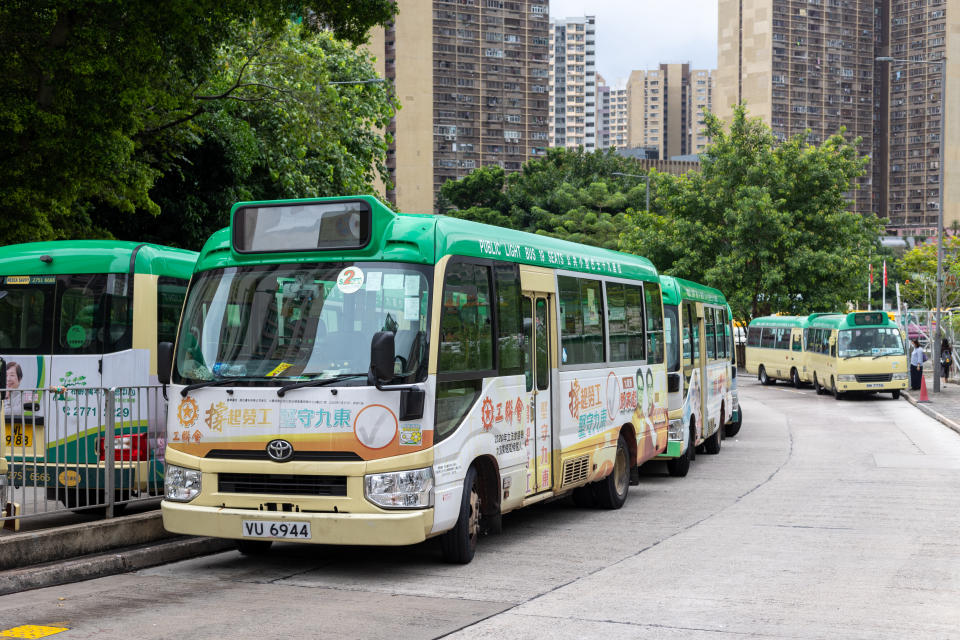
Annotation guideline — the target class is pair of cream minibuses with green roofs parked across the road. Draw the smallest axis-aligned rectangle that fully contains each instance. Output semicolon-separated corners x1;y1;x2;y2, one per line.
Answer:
746;311;909;400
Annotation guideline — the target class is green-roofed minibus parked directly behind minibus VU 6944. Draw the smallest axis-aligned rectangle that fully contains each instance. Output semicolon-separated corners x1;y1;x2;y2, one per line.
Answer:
658;275;742;477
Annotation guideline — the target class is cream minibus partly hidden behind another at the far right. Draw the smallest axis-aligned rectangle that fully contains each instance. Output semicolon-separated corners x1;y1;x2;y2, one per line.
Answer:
745;316;809;387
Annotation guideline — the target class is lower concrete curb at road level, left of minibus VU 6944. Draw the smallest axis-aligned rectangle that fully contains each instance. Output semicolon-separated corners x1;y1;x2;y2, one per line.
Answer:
0;537;234;595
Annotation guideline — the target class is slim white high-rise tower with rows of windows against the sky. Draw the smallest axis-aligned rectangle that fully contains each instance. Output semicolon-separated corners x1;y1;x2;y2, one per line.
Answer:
550;16;597;151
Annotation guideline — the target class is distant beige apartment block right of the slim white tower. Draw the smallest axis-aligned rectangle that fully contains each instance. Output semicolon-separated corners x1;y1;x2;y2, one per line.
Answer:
626;63;713;159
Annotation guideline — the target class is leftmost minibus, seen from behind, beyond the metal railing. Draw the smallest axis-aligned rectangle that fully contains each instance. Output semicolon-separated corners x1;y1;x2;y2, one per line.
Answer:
0;240;197;515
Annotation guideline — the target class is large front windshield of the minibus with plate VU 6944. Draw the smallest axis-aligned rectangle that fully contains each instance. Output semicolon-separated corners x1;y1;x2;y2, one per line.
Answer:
174;262;432;384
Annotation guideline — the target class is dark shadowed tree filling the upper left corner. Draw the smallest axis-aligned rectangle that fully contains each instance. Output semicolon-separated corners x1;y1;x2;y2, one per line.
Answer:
0;0;396;243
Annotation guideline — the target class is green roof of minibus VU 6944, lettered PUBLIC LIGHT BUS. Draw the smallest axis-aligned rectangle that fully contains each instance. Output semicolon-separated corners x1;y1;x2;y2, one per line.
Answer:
197;196;657;281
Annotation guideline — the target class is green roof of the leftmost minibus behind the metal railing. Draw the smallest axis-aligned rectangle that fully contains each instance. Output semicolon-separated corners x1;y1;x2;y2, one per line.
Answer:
0;240;199;279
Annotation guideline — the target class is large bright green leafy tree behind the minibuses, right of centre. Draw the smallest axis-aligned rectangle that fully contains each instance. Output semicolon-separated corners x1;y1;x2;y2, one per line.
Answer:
620;106;880;319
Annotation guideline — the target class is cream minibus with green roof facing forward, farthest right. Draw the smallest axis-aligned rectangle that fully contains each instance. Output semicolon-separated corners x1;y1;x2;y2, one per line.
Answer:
803;311;910;400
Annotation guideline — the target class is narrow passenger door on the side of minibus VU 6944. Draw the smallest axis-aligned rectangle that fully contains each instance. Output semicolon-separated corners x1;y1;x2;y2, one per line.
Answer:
523;292;553;496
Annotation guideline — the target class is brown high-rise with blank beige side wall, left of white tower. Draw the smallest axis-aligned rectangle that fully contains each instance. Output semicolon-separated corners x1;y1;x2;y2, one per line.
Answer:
369;0;550;212
